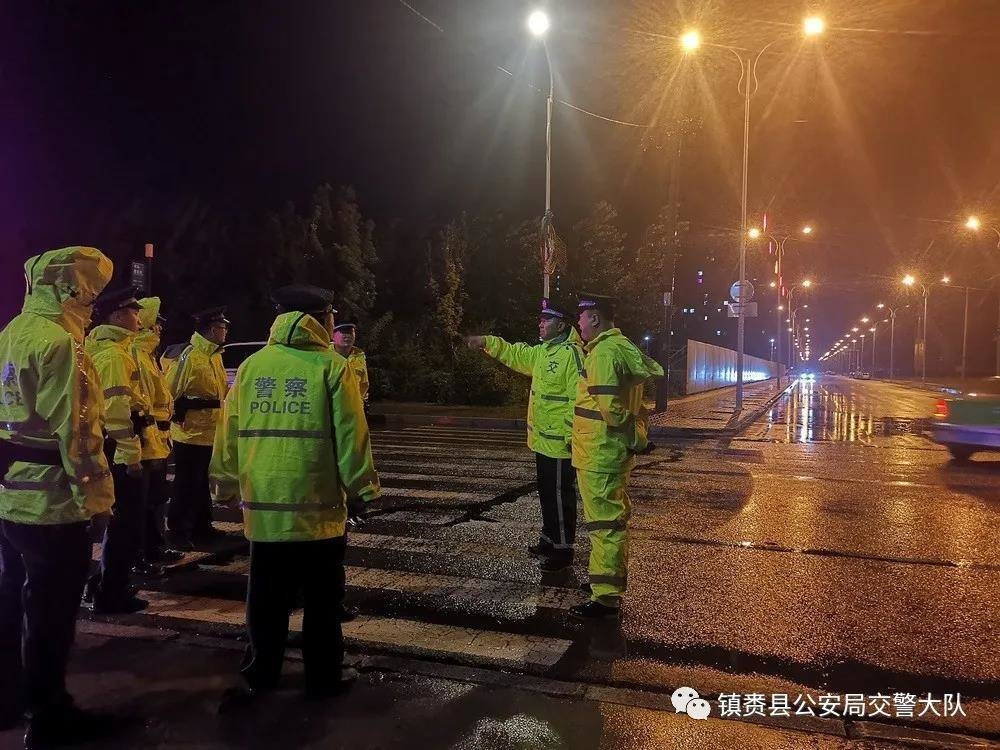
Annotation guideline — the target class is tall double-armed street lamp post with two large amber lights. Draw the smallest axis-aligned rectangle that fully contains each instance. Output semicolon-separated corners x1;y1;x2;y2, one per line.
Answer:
680;16;826;414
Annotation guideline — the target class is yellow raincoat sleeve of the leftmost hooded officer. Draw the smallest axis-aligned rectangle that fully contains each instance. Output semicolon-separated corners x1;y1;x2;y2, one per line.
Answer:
35;338;114;505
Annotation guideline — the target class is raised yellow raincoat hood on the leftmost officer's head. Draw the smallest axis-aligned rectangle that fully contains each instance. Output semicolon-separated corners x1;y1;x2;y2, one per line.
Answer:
21;247;114;341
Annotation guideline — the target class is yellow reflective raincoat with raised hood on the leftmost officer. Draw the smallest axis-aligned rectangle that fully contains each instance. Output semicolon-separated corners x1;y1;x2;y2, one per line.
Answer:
0;247;114;524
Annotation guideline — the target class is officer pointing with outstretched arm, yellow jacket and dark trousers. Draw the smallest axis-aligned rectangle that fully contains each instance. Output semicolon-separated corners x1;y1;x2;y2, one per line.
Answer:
466;299;583;572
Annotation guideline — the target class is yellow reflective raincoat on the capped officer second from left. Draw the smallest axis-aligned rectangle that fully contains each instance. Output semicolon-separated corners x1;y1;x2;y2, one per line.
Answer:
86;324;149;466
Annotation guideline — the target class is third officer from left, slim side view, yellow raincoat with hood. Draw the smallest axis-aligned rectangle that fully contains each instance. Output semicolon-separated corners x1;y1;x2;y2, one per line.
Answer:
132;297;183;575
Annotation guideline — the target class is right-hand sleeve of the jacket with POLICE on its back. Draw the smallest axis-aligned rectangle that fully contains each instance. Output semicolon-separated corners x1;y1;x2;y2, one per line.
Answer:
327;366;382;503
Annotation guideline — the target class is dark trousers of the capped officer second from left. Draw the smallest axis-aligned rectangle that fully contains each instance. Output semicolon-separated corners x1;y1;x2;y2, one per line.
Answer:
97;464;146;602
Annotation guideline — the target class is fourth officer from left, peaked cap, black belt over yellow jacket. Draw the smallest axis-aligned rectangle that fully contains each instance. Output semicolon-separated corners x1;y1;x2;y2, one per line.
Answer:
161;307;229;550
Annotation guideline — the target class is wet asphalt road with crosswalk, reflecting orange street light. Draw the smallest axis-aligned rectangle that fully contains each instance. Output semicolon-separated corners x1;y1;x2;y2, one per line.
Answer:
64;378;1000;747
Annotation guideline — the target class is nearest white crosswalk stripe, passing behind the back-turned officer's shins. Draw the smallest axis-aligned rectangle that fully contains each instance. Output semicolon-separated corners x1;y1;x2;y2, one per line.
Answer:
140;591;571;670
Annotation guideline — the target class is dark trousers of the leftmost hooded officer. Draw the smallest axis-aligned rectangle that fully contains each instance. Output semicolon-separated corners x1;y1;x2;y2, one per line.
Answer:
0;521;90;716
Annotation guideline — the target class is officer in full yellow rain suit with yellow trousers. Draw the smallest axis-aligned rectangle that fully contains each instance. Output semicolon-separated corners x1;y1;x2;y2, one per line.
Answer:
570;294;663;619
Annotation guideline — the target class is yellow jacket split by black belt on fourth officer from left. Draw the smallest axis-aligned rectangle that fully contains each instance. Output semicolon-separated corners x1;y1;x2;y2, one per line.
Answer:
161;333;228;445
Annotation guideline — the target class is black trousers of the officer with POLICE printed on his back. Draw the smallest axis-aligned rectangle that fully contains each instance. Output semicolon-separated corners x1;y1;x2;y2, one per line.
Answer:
241;537;346;690
